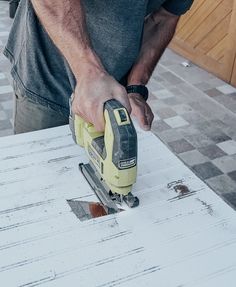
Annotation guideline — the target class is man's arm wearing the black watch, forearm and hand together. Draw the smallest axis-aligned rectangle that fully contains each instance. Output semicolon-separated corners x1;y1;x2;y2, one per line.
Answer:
128;8;179;130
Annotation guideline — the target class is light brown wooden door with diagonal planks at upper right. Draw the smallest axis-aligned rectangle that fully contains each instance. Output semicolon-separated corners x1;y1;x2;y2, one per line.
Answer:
170;0;236;84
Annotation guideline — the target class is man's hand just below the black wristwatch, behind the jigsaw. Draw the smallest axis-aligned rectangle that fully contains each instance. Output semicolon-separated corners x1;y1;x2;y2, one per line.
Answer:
129;93;154;131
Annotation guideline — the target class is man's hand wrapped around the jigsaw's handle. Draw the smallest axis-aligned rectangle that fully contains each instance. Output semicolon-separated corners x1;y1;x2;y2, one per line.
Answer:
72;64;131;131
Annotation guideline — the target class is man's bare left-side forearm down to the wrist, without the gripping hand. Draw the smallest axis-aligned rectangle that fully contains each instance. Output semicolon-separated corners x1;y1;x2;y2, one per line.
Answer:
31;0;103;77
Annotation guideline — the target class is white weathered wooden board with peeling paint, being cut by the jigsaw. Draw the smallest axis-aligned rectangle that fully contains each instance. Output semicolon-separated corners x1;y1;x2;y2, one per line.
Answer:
0;126;236;287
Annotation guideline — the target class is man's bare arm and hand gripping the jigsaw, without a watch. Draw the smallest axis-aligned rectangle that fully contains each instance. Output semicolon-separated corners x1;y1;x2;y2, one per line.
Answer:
31;0;130;130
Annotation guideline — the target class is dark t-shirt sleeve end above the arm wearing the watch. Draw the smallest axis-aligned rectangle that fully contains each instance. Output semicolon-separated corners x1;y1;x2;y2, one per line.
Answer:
162;0;194;15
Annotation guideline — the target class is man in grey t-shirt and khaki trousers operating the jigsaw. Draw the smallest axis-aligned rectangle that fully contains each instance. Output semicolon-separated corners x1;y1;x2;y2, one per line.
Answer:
4;0;193;133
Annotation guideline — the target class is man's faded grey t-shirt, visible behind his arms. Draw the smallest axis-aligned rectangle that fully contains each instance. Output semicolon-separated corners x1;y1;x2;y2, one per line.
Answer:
4;0;193;115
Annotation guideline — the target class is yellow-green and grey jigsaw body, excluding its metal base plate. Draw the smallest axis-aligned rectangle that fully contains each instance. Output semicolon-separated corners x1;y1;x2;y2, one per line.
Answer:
70;99;137;195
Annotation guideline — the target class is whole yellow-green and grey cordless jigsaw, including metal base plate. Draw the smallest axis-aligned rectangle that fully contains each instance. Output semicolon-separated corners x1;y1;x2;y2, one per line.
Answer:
70;99;139;212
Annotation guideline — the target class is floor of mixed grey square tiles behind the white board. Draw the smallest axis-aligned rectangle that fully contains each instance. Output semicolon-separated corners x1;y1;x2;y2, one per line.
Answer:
0;1;236;208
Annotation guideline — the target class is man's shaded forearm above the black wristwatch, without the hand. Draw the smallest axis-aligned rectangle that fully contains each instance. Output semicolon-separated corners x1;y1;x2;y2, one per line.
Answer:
128;9;179;85
